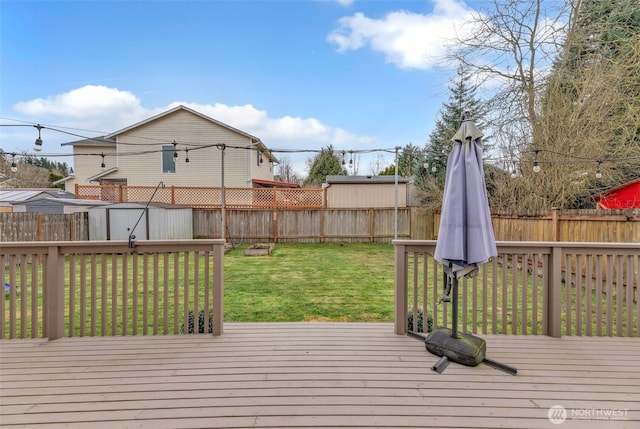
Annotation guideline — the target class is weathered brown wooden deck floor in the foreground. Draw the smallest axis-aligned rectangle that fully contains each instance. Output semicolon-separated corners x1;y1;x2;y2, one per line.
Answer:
0;323;640;429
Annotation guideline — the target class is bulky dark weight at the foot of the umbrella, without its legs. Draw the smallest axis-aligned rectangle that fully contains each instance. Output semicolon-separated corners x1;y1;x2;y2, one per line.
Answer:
425;328;487;366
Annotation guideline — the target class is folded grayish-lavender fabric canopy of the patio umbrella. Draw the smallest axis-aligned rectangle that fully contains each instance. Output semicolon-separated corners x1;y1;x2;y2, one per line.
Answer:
434;112;498;278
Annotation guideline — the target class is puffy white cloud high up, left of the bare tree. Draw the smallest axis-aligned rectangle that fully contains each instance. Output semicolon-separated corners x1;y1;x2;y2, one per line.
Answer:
327;0;472;70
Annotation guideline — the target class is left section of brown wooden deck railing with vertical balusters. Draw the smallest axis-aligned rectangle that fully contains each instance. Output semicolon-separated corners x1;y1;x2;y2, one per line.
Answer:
0;240;224;339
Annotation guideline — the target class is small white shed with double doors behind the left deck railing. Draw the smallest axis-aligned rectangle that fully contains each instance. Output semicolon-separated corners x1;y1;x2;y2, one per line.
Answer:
89;203;193;240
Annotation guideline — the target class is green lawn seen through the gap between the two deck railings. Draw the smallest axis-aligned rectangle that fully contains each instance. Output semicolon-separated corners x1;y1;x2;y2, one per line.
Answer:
224;243;395;322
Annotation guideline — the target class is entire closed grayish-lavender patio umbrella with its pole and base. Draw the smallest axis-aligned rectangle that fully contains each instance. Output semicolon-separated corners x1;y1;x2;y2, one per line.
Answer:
414;112;517;375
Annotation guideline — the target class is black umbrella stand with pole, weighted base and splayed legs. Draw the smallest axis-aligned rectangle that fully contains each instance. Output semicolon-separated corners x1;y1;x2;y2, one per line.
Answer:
408;266;518;375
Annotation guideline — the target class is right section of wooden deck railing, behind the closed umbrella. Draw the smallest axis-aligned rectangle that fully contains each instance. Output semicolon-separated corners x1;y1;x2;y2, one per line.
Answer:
394;240;640;337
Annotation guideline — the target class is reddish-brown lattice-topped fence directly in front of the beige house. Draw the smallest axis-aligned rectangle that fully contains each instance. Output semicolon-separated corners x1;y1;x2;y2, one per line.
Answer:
75;184;325;210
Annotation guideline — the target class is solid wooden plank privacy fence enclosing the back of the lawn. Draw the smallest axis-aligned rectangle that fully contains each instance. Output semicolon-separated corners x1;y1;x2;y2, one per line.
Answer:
0;207;640;243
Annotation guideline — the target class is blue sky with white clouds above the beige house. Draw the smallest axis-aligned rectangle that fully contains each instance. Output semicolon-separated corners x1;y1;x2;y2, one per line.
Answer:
0;0;480;174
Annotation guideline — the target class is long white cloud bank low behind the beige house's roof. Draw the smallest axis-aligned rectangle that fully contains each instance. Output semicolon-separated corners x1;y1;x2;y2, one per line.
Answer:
15;85;375;149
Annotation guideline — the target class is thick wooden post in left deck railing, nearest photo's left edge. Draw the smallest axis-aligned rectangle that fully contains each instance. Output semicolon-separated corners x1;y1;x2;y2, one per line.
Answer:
44;246;65;340
